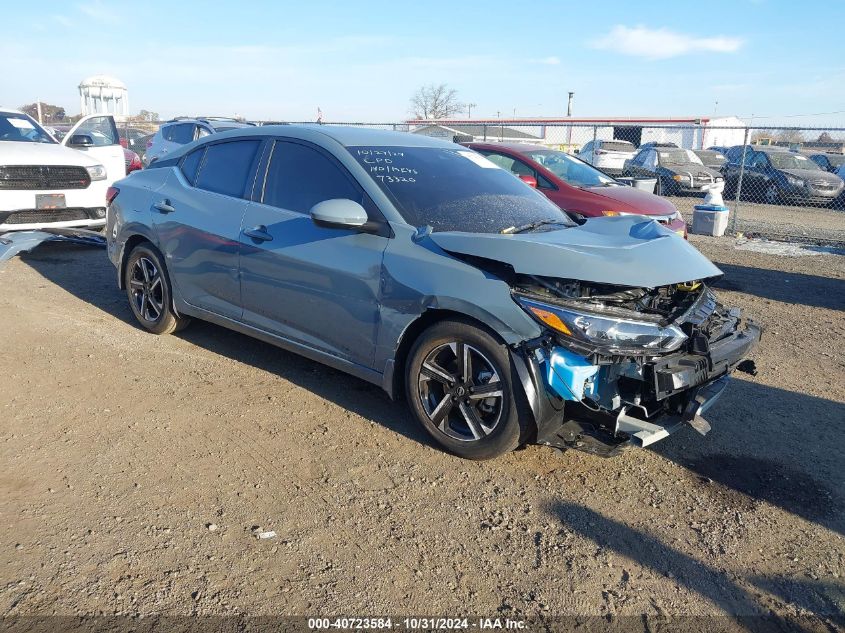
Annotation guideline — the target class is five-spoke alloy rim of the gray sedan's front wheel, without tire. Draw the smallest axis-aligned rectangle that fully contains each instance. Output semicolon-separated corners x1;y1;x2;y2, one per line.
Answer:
417;341;505;442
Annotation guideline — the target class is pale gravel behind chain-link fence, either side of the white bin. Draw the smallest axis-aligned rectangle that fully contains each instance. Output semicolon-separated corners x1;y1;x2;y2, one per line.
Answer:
669;196;845;246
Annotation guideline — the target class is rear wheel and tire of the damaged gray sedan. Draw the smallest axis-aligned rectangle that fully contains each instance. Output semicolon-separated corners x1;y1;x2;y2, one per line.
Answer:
123;244;190;334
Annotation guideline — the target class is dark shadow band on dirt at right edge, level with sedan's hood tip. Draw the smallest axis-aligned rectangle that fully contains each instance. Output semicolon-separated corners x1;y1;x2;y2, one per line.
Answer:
710;262;845;310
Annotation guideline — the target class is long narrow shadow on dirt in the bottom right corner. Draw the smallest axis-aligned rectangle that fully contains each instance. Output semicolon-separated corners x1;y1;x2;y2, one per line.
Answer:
547;502;842;632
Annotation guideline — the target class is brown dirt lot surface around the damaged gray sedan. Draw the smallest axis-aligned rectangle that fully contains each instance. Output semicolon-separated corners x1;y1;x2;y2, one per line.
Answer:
0;238;845;630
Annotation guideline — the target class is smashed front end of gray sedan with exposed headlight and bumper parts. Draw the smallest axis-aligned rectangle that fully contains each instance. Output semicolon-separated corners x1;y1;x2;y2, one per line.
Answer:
511;275;761;456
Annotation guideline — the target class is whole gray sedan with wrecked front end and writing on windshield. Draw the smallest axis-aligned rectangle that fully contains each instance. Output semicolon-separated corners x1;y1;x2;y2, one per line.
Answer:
107;126;760;459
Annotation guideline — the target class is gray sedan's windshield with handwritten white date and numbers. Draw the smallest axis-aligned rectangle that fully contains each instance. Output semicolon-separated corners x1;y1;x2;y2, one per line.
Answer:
347;146;574;233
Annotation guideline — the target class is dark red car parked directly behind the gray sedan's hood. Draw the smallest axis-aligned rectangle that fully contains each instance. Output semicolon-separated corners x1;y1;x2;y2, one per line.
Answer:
466;143;687;237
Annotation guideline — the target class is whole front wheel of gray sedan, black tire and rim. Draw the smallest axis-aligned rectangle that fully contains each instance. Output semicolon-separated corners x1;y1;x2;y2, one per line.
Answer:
405;320;531;460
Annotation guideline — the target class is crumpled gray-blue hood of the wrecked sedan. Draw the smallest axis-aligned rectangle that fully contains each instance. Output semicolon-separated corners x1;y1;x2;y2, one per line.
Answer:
431;216;723;288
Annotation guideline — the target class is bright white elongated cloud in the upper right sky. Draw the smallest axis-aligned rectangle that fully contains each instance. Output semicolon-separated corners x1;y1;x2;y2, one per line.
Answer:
592;25;743;59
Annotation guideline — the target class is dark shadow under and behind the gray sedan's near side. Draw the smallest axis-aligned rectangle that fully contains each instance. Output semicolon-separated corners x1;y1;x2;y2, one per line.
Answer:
21;243;434;446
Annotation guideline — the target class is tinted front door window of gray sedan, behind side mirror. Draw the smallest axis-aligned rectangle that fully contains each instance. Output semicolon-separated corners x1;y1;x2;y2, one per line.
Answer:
264;141;368;213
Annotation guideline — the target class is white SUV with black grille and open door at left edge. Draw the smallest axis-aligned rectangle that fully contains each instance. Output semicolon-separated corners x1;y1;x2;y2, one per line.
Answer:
0;108;126;233
